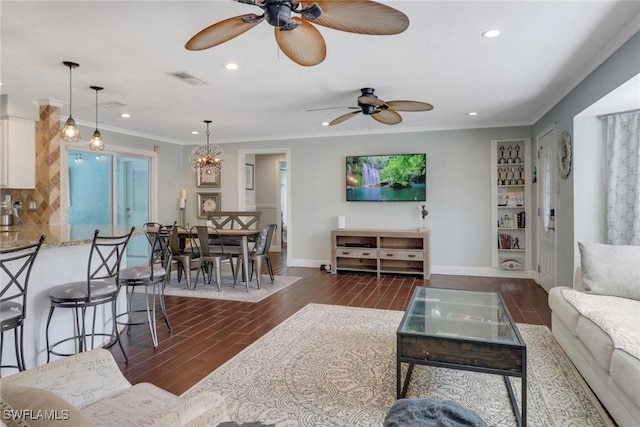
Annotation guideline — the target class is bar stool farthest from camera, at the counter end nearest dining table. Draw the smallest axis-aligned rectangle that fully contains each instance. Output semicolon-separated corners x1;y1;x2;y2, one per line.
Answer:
117;227;173;348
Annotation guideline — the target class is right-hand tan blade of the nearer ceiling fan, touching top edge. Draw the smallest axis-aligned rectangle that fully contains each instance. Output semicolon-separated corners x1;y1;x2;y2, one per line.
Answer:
300;0;409;35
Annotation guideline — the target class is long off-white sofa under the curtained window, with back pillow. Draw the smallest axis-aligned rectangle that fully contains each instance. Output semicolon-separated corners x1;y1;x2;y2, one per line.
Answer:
549;243;640;427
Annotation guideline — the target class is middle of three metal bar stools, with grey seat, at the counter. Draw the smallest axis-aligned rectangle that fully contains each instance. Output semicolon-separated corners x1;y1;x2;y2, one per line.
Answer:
46;227;135;363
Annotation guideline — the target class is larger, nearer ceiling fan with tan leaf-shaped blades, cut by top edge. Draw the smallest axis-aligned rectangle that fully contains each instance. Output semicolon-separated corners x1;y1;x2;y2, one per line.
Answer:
185;0;409;66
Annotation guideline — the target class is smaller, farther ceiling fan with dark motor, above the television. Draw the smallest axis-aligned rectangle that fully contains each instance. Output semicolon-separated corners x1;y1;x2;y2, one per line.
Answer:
309;87;433;126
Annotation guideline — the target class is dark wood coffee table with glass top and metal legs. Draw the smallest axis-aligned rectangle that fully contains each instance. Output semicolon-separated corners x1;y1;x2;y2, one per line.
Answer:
397;287;527;426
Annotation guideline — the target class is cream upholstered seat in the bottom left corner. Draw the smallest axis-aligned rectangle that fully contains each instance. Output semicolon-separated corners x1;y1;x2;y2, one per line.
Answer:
0;349;229;427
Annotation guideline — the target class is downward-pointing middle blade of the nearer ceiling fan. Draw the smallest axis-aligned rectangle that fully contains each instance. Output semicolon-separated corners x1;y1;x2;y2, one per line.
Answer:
274;17;327;67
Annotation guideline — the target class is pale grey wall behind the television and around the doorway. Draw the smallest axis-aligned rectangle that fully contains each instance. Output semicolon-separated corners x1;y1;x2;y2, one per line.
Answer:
199;127;530;275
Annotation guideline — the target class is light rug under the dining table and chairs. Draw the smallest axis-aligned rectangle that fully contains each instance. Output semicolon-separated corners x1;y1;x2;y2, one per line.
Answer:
164;270;301;302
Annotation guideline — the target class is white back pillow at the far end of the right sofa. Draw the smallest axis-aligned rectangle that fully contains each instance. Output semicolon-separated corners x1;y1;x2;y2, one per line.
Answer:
578;242;640;300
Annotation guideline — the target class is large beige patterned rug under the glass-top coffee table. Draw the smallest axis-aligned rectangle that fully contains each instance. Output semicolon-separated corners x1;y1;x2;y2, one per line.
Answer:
185;304;614;427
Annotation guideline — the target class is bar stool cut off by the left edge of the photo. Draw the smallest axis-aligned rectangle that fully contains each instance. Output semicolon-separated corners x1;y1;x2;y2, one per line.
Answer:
0;236;45;376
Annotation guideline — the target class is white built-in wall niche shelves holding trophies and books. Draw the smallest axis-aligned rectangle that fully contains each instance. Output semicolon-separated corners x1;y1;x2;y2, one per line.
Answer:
491;138;533;275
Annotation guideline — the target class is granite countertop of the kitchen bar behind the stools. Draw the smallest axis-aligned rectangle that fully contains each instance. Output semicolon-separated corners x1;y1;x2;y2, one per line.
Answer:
0;224;144;250
